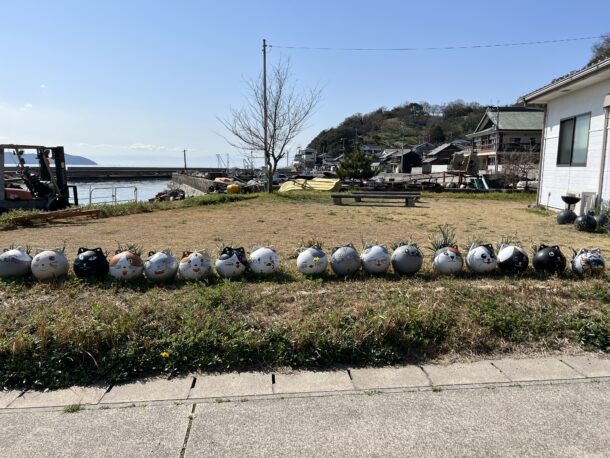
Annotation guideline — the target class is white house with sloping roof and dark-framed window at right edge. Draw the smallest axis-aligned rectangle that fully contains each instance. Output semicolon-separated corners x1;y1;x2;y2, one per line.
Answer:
521;59;610;212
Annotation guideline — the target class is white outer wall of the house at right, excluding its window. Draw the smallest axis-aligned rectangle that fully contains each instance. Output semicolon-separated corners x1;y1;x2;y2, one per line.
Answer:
538;80;610;209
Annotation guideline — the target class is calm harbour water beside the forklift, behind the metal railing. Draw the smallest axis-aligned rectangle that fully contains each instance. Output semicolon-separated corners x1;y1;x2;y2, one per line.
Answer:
69;178;169;205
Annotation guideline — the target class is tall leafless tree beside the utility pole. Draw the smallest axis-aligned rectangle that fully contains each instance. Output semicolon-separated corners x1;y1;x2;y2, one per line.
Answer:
218;61;322;192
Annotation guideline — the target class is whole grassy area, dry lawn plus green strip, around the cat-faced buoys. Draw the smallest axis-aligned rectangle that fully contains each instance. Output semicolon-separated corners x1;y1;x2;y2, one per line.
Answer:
0;194;610;387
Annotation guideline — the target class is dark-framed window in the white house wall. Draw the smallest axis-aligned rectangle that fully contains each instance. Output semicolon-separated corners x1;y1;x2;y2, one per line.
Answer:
557;113;591;165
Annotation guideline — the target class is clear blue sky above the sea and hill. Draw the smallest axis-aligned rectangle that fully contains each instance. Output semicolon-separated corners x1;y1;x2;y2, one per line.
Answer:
0;0;610;167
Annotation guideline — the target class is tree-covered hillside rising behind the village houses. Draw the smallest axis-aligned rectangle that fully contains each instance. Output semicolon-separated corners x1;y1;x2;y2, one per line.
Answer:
308;100;487;154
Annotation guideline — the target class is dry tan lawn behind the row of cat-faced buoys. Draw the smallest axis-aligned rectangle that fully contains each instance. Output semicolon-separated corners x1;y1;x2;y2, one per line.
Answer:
0;196;610;259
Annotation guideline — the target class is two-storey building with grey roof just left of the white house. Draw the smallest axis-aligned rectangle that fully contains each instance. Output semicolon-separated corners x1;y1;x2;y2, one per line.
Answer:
466;107;544;172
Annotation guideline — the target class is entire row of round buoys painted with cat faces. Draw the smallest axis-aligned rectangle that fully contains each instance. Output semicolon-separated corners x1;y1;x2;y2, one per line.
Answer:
0;244;605;282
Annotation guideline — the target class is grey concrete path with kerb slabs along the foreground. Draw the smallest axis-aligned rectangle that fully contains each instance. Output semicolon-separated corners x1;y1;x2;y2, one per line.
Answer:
0;356;610;456
